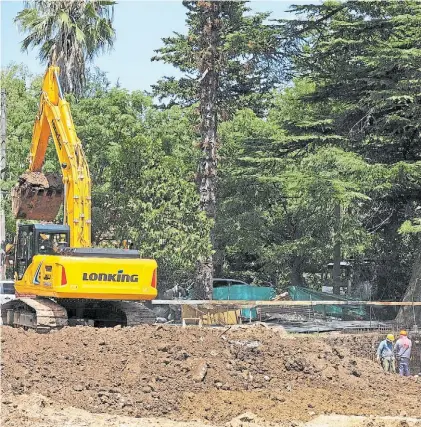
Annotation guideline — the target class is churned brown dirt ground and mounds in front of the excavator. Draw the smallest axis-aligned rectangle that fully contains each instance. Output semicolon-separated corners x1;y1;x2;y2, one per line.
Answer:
1;324;421;427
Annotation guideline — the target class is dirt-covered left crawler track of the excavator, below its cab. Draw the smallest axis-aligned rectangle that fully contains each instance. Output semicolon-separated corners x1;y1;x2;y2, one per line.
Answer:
1;297;67;333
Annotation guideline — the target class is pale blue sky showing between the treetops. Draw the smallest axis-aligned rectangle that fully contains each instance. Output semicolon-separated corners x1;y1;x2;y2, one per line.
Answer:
0;0;312;90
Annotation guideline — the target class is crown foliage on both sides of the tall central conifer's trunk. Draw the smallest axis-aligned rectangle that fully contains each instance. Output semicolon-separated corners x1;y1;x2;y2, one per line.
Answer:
152;1;287;119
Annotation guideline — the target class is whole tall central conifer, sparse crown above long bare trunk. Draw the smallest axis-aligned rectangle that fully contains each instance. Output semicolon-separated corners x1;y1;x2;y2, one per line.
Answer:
153;1;283;298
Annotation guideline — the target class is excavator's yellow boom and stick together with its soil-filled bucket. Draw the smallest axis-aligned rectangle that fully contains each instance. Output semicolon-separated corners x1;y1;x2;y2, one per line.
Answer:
12;66;91;248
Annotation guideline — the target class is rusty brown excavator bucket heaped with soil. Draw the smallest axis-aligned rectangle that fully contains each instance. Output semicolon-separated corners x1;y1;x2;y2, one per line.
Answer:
12;172;64;221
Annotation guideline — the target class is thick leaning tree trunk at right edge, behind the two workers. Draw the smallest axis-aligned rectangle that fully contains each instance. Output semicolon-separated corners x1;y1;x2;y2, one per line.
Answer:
396;247;421;328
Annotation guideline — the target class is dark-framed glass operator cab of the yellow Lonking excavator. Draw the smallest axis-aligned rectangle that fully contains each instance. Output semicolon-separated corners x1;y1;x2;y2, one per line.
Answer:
14;224;70;280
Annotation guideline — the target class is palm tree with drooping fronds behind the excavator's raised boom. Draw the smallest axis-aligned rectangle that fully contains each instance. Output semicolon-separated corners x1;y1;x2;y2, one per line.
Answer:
15;0;115;96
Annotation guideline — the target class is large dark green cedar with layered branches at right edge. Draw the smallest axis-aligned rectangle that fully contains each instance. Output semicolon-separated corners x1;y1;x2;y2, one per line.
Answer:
283;0;421;299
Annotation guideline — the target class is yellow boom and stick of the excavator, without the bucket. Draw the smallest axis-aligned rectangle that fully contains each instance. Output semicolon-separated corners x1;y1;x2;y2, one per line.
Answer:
29;66;91;248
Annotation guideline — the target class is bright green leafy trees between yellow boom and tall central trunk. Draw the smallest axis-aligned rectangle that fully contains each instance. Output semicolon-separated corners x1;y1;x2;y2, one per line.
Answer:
72;83;210;283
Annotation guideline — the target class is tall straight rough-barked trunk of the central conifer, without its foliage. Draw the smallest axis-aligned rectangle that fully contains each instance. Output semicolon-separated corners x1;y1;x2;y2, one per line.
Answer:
196;1;221;299
